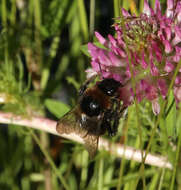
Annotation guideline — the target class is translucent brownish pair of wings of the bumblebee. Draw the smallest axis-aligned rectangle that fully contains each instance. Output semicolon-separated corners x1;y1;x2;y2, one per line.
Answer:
56;107;99;158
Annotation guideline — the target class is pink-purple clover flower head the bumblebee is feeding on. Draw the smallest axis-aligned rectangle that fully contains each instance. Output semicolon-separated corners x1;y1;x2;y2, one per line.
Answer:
87;0;181;114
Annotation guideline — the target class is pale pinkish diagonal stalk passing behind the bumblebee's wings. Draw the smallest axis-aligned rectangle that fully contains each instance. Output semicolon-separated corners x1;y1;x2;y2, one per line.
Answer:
0;112;173;169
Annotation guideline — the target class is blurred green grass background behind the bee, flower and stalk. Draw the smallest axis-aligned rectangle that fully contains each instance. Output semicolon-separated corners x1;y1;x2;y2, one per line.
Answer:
0;0;181;190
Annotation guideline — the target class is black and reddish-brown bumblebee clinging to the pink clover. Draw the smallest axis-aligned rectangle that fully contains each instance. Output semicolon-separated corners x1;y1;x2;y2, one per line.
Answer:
56;78;125;158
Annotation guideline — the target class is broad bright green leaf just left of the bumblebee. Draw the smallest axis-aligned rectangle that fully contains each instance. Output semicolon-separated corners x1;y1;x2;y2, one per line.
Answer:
45;99;70;118
